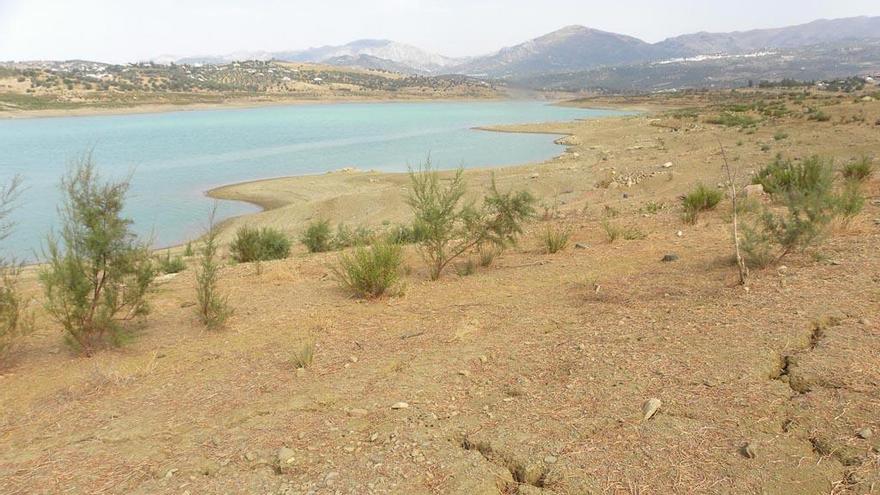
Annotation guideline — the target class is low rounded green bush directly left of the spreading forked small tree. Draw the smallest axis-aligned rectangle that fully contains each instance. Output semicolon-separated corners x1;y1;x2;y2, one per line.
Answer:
335;242;403;298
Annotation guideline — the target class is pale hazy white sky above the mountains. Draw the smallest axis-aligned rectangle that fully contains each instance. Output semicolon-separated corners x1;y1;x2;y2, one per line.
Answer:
0;0;880;62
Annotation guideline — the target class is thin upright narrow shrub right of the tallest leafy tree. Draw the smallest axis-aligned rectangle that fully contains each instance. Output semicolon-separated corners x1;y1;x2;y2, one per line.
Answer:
196;206;232;330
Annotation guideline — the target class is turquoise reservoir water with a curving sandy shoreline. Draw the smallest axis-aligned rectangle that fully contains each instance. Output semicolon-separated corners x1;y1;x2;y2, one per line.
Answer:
0;102;615;259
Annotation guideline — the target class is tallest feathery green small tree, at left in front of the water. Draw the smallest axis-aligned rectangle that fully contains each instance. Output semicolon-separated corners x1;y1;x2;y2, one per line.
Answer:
39;154;155;355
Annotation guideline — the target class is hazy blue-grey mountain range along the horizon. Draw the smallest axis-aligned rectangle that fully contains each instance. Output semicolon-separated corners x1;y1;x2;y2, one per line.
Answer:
163;17;880;89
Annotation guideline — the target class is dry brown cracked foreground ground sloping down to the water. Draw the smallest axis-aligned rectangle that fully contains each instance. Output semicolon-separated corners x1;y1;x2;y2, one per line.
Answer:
0;87;880;495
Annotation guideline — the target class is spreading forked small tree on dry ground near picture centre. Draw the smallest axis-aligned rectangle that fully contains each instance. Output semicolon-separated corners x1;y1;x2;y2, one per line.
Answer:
407;161;535;280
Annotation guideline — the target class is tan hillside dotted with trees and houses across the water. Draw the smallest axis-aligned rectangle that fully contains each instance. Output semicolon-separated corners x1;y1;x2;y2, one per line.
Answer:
0;61;497;116
